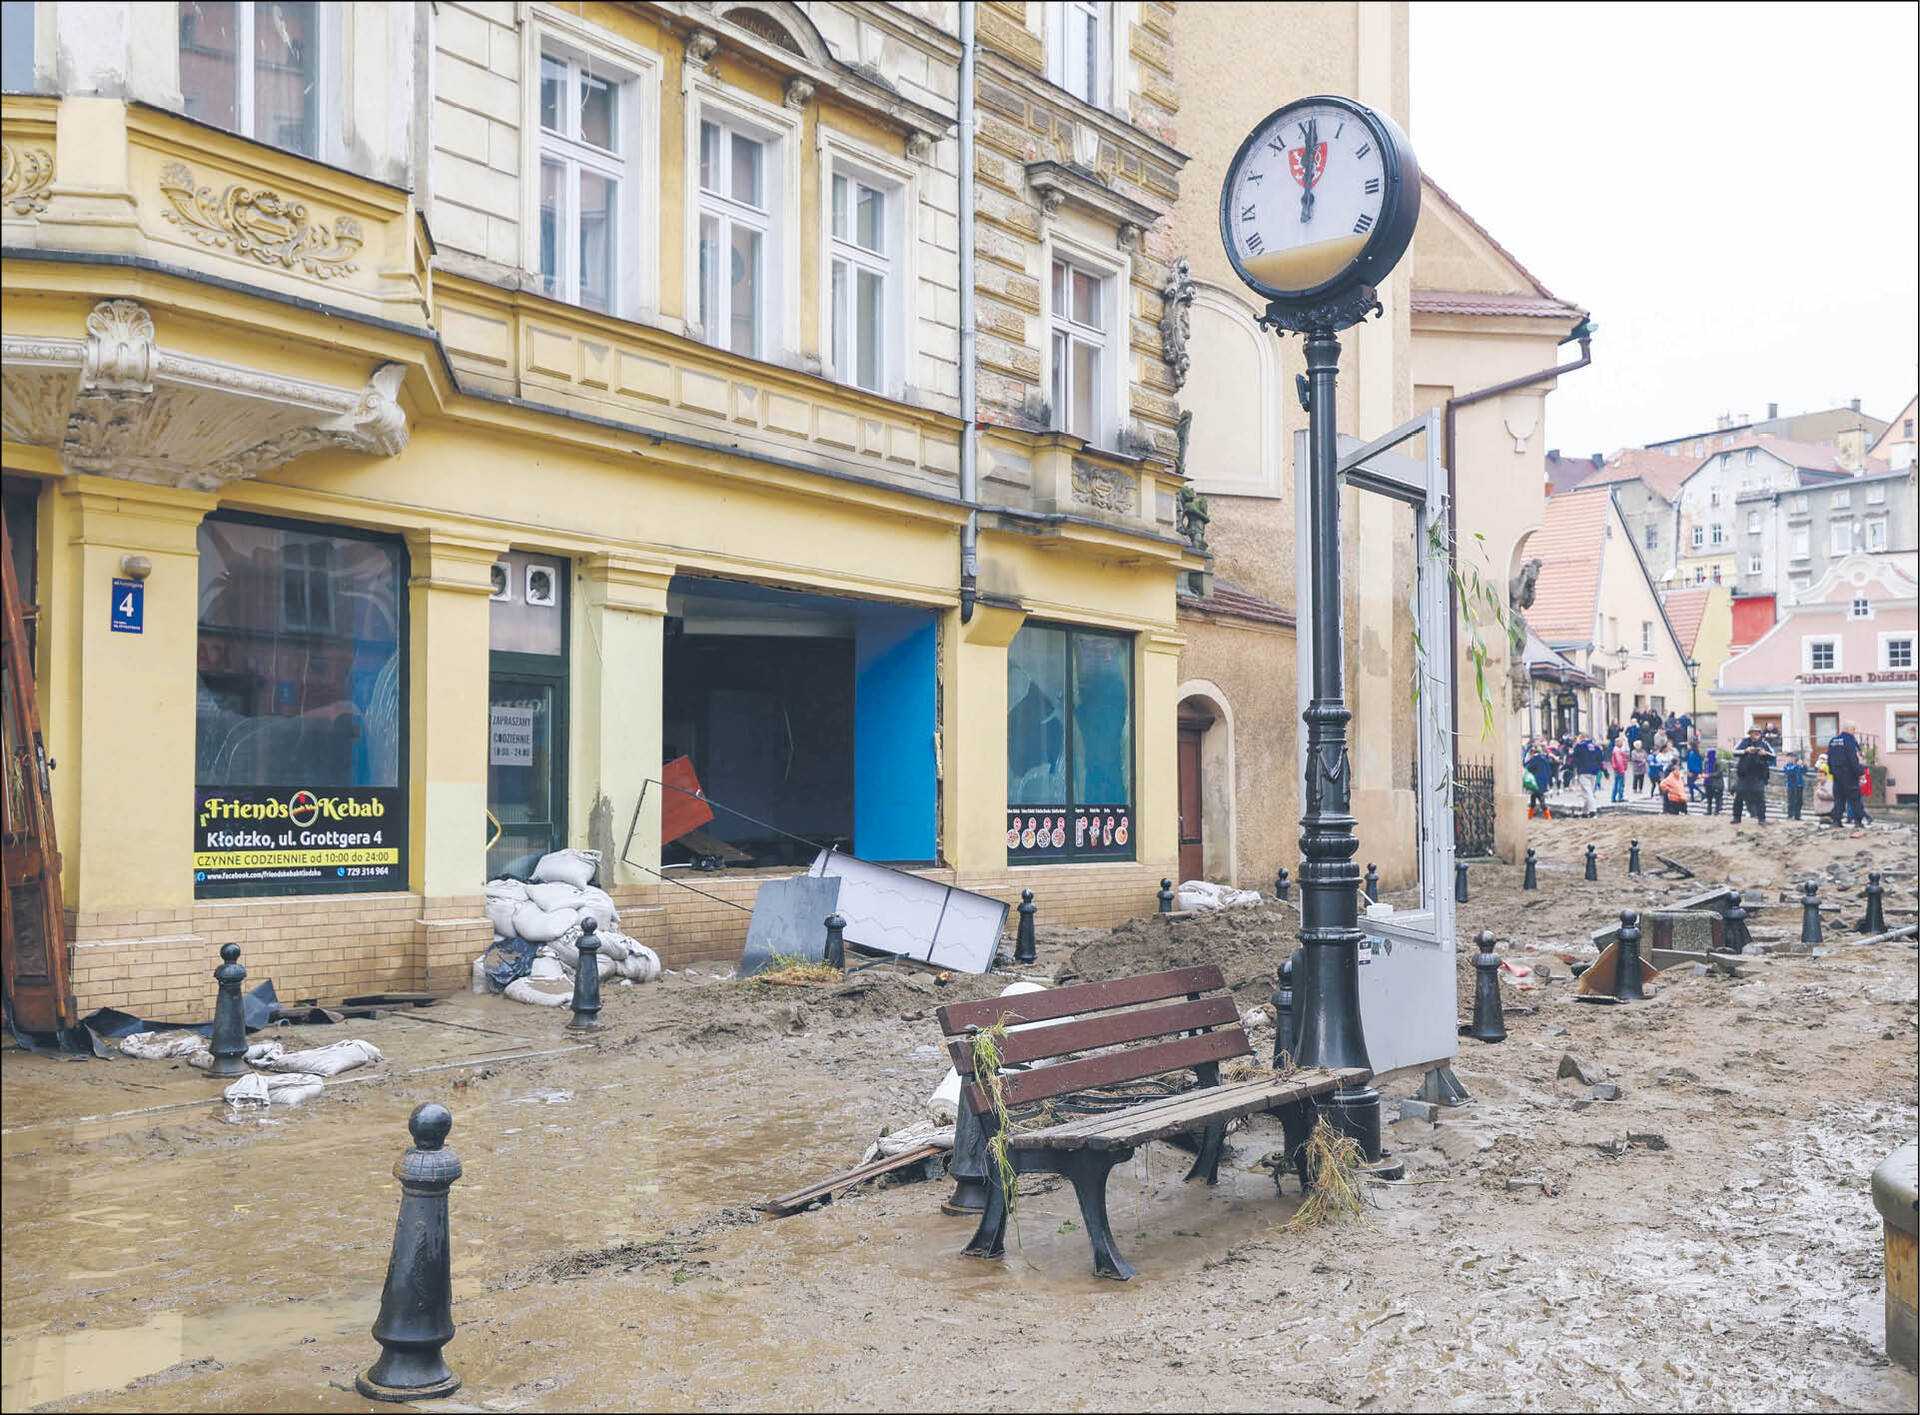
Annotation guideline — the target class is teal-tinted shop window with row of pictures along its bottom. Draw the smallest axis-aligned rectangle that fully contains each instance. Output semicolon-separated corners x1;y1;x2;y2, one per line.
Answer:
1006;624;1135;864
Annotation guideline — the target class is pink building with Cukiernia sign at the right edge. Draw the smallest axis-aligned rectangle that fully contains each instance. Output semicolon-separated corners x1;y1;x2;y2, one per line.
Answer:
1715;555;1920;804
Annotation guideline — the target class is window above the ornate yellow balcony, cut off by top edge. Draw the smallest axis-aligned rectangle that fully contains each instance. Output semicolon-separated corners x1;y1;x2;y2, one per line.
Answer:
180;0;321;157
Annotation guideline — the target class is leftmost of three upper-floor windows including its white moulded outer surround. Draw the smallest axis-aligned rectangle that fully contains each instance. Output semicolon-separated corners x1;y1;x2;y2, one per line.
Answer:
520;6;660;319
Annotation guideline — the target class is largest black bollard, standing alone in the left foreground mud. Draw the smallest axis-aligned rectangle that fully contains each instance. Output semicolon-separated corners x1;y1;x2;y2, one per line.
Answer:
353;1098;458;1402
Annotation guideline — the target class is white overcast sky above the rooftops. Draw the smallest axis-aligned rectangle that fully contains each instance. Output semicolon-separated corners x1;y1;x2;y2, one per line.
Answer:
1411;0;1920;453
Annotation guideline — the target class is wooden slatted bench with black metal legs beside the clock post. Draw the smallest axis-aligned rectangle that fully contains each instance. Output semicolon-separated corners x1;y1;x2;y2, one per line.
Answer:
937;966;1371;1281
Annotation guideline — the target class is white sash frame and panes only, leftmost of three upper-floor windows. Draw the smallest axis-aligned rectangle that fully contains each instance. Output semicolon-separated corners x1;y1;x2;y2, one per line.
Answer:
540;54;630;313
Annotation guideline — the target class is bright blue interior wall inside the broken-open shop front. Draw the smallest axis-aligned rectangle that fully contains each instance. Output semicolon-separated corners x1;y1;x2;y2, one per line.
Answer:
852;605;937;860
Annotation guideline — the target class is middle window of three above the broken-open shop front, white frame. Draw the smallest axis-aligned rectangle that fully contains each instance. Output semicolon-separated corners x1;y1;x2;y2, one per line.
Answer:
699;119;774;359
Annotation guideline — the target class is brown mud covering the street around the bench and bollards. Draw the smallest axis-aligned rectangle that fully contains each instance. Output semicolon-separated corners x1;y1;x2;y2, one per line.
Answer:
0;816;1916;1411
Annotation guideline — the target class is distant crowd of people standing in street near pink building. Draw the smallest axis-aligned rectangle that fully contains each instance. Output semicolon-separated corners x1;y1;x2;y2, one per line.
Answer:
1521;710;1872;833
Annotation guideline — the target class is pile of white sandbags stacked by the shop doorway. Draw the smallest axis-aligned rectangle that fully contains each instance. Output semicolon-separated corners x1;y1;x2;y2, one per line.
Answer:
474;851;660;1008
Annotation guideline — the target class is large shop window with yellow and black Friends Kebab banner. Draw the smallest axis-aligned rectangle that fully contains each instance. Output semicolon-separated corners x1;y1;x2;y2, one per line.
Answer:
194;515;407;897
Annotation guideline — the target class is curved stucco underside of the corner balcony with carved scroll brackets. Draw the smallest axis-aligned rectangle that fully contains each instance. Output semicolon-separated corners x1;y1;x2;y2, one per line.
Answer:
0;300;407;492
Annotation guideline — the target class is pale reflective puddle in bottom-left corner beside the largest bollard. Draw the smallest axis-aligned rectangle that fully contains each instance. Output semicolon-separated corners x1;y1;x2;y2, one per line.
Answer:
0;1290;366;1409
